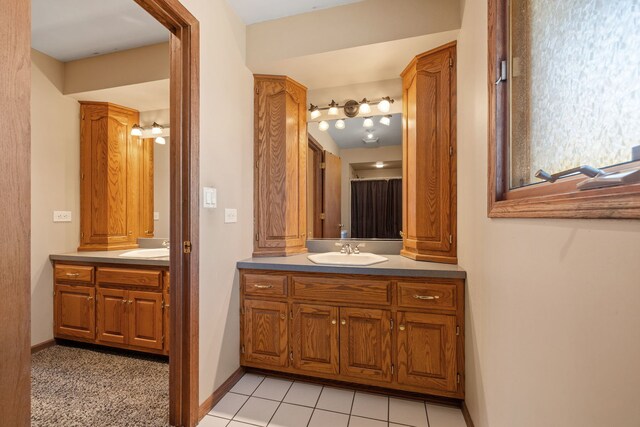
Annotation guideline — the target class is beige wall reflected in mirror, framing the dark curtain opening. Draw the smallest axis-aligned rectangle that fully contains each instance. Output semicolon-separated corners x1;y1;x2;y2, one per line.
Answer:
340;145;402;236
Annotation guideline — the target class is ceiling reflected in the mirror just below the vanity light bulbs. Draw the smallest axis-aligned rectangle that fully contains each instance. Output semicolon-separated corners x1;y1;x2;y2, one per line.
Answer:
322;113;402;149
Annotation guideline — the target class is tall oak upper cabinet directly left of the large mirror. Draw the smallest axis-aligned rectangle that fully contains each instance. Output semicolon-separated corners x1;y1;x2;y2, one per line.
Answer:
253;75;307;256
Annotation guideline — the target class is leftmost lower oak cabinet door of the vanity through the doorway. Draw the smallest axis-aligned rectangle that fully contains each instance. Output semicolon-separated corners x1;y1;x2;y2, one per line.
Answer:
54;285;96;340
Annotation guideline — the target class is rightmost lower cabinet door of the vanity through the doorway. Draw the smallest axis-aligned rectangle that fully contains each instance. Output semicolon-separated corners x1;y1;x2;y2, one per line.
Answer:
127;291;163;350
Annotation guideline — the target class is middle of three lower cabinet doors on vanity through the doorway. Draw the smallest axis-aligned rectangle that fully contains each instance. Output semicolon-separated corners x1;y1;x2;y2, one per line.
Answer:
96;288;127;344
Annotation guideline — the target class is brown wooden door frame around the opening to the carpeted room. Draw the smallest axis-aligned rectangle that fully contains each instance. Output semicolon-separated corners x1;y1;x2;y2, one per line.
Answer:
0;0;200;427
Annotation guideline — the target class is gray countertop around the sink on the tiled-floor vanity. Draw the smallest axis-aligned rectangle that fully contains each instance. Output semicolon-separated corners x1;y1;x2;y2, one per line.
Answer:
237;254;467;279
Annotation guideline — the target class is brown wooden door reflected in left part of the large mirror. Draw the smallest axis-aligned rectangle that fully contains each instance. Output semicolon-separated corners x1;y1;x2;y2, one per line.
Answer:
322;151;342;238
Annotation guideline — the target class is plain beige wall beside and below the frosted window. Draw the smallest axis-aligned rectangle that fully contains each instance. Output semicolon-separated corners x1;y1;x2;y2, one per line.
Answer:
457;0;640;427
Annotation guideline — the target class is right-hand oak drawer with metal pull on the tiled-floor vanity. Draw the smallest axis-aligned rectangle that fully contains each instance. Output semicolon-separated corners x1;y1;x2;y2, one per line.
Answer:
398;282;458;311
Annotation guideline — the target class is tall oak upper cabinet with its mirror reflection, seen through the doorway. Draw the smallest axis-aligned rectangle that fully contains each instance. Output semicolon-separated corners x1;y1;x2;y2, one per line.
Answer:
78;102;153;251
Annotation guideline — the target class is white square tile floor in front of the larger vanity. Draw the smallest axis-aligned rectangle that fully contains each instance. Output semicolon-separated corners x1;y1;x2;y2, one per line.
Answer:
200;373;466;427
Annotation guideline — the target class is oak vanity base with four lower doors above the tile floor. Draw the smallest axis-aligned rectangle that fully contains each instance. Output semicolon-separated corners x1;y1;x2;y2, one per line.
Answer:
240;270;464;398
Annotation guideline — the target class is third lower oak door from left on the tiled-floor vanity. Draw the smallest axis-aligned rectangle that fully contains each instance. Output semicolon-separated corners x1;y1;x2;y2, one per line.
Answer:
340;308;392;381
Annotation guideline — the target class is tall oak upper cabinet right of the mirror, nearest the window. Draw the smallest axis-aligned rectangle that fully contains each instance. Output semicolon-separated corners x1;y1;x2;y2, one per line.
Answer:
401;42;457;264
